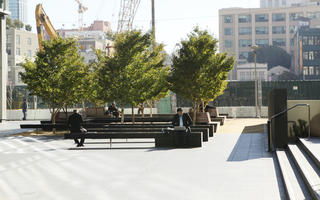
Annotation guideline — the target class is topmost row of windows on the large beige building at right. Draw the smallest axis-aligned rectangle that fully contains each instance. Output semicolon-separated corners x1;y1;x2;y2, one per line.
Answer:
223;12;320;24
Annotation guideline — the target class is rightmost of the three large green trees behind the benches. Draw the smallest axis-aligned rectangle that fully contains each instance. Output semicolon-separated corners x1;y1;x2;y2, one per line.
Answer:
169;27;234;123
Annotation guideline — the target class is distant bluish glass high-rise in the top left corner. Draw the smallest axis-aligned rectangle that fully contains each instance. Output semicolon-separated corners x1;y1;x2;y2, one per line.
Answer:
9;0;28;24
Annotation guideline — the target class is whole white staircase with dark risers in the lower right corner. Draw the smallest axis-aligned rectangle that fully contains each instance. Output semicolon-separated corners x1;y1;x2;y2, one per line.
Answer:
276;139;320;200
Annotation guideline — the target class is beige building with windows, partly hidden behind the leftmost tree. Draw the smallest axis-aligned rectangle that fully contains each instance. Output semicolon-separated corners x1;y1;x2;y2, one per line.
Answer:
7;29;39;85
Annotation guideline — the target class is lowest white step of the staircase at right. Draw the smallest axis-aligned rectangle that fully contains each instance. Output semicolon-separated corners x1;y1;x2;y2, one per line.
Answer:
276;150;311;200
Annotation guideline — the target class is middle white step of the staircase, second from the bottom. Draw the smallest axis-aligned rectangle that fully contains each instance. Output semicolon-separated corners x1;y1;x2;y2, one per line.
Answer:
288;144;320;200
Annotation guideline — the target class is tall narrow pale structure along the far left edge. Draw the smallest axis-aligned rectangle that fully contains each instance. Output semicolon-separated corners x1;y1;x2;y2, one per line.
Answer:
0;0;10;122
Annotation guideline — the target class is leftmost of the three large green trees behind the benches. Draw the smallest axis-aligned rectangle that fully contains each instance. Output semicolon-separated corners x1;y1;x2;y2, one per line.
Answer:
20;37;88;126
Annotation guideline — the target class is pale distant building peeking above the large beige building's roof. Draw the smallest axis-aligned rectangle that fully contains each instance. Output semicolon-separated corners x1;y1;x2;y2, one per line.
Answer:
260;0;317;8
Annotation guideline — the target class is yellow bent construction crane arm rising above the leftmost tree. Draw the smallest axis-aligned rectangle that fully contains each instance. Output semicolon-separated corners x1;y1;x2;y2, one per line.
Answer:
35;4;59;50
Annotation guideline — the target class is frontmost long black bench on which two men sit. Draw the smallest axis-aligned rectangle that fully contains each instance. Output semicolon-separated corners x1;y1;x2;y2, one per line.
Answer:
64;132;202;148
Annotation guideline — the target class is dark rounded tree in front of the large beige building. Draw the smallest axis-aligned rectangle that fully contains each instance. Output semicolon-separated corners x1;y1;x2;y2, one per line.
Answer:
247;46;291;69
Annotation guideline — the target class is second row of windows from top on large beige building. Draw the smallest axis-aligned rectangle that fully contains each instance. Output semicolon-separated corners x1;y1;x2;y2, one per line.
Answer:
224;26;295;36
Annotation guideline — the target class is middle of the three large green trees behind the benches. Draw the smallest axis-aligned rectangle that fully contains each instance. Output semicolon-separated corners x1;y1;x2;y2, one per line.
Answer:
98;30;169;122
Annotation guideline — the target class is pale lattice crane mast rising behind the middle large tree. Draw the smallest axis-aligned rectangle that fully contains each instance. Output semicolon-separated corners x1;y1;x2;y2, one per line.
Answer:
117;0;140;33
